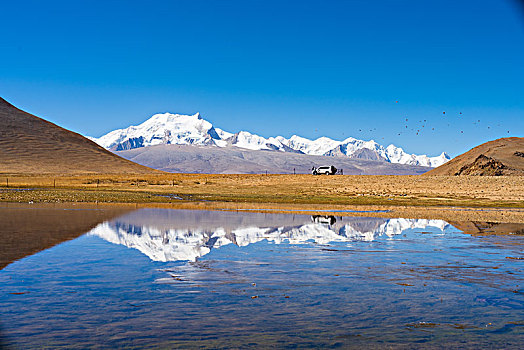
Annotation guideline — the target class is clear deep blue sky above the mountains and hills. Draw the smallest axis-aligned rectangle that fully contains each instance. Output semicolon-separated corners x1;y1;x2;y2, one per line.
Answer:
0;0;524;155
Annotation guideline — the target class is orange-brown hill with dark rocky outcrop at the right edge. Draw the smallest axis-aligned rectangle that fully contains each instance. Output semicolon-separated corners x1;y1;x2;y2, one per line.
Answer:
425;137;524;176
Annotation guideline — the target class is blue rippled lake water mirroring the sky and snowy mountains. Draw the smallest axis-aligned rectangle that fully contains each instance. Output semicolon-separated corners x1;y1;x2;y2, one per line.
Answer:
0;209;524;349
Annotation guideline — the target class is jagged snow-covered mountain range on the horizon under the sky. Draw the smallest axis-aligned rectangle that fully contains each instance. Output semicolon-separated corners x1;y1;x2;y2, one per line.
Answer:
88;113;450;167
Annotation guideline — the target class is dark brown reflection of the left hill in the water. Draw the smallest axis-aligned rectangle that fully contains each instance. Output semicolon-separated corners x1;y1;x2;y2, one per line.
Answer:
0;203;135;270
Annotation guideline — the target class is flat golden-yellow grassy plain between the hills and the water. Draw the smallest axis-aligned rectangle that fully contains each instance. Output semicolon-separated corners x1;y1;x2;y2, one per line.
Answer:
0;174;524;222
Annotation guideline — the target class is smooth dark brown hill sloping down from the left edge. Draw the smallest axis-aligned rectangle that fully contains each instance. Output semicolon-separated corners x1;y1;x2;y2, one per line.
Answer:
0;97;157;174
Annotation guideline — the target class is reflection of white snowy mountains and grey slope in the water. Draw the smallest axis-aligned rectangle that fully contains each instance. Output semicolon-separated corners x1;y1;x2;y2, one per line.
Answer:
89;209;448;261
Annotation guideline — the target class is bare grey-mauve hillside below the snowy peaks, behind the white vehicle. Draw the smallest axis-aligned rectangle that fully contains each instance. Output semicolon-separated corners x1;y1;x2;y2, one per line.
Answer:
116;145;431;175
